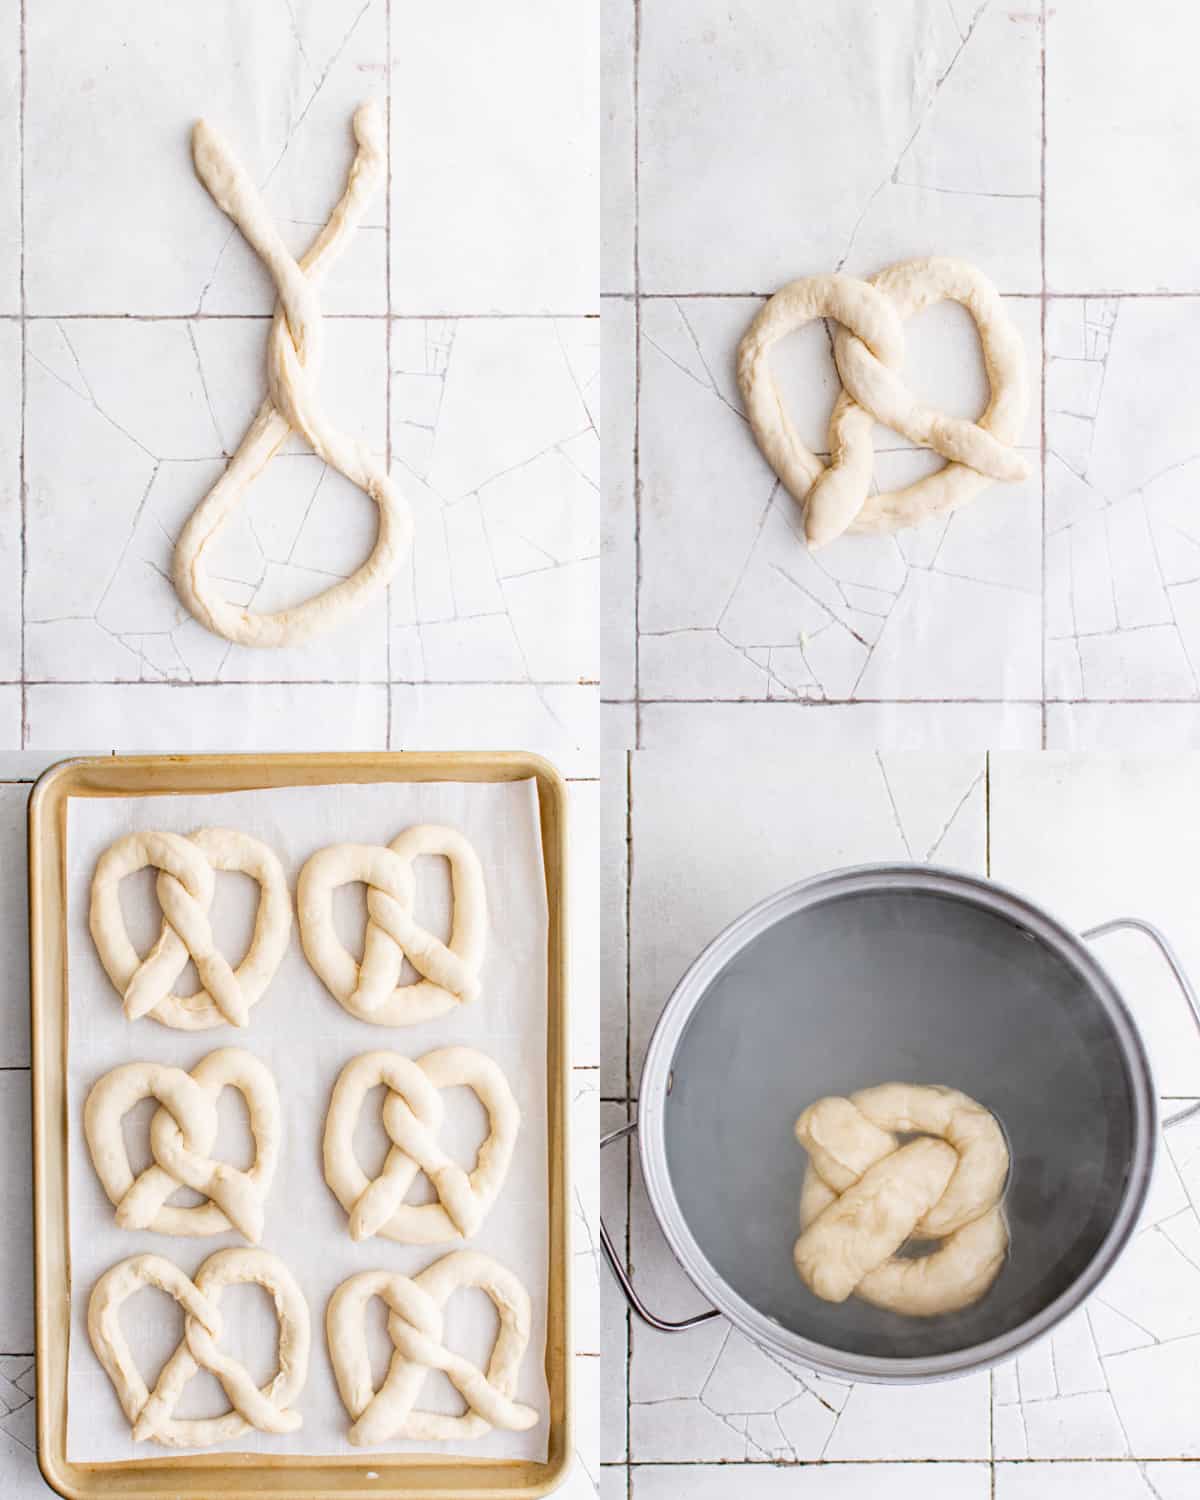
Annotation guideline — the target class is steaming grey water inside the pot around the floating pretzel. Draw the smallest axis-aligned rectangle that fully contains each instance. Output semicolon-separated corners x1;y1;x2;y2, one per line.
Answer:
663;890;1136;1358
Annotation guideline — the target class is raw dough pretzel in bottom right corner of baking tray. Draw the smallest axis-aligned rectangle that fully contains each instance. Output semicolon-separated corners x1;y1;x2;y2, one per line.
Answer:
326;1250;539;1448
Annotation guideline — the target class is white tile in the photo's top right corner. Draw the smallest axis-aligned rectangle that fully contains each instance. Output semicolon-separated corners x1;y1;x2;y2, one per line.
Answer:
1046;0;1200;291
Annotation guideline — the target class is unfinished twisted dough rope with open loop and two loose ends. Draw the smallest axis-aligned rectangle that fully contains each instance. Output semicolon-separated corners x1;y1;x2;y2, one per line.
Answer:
174;101;413;647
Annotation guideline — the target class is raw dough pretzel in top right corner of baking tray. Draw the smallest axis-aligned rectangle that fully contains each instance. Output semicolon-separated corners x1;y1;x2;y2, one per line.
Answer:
297;824;488;1026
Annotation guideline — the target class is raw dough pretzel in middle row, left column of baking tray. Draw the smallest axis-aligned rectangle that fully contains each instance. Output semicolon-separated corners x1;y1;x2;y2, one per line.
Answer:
84;1047;282;1245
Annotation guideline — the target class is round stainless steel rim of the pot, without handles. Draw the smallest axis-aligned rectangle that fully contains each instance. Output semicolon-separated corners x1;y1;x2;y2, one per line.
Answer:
638;863;1158;1385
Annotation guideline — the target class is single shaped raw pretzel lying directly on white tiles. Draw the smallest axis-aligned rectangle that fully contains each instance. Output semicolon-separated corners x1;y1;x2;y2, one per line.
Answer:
738;257;1029;548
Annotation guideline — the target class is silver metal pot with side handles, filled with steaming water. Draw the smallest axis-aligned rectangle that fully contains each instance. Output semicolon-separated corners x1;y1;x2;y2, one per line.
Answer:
602;864;1200;1383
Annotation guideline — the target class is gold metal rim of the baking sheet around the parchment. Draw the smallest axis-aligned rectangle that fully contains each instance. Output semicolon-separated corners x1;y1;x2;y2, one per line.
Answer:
30;753;572;1500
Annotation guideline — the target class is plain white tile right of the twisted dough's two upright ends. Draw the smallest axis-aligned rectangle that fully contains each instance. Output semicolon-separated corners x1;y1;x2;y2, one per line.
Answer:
392;0;599;312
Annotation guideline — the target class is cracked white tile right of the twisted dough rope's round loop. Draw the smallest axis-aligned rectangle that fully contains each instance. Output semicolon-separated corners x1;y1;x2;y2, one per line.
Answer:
390;318;600;683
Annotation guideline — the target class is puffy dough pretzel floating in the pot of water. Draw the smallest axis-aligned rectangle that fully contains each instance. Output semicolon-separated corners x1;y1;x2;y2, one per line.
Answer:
795;1083;1008;1317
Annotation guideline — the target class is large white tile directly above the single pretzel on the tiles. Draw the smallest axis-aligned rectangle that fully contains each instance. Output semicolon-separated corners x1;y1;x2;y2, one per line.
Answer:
639;0;1041;293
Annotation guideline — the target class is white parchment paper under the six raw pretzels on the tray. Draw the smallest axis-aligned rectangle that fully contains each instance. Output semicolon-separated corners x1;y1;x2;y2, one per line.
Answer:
68;780;549;1463
